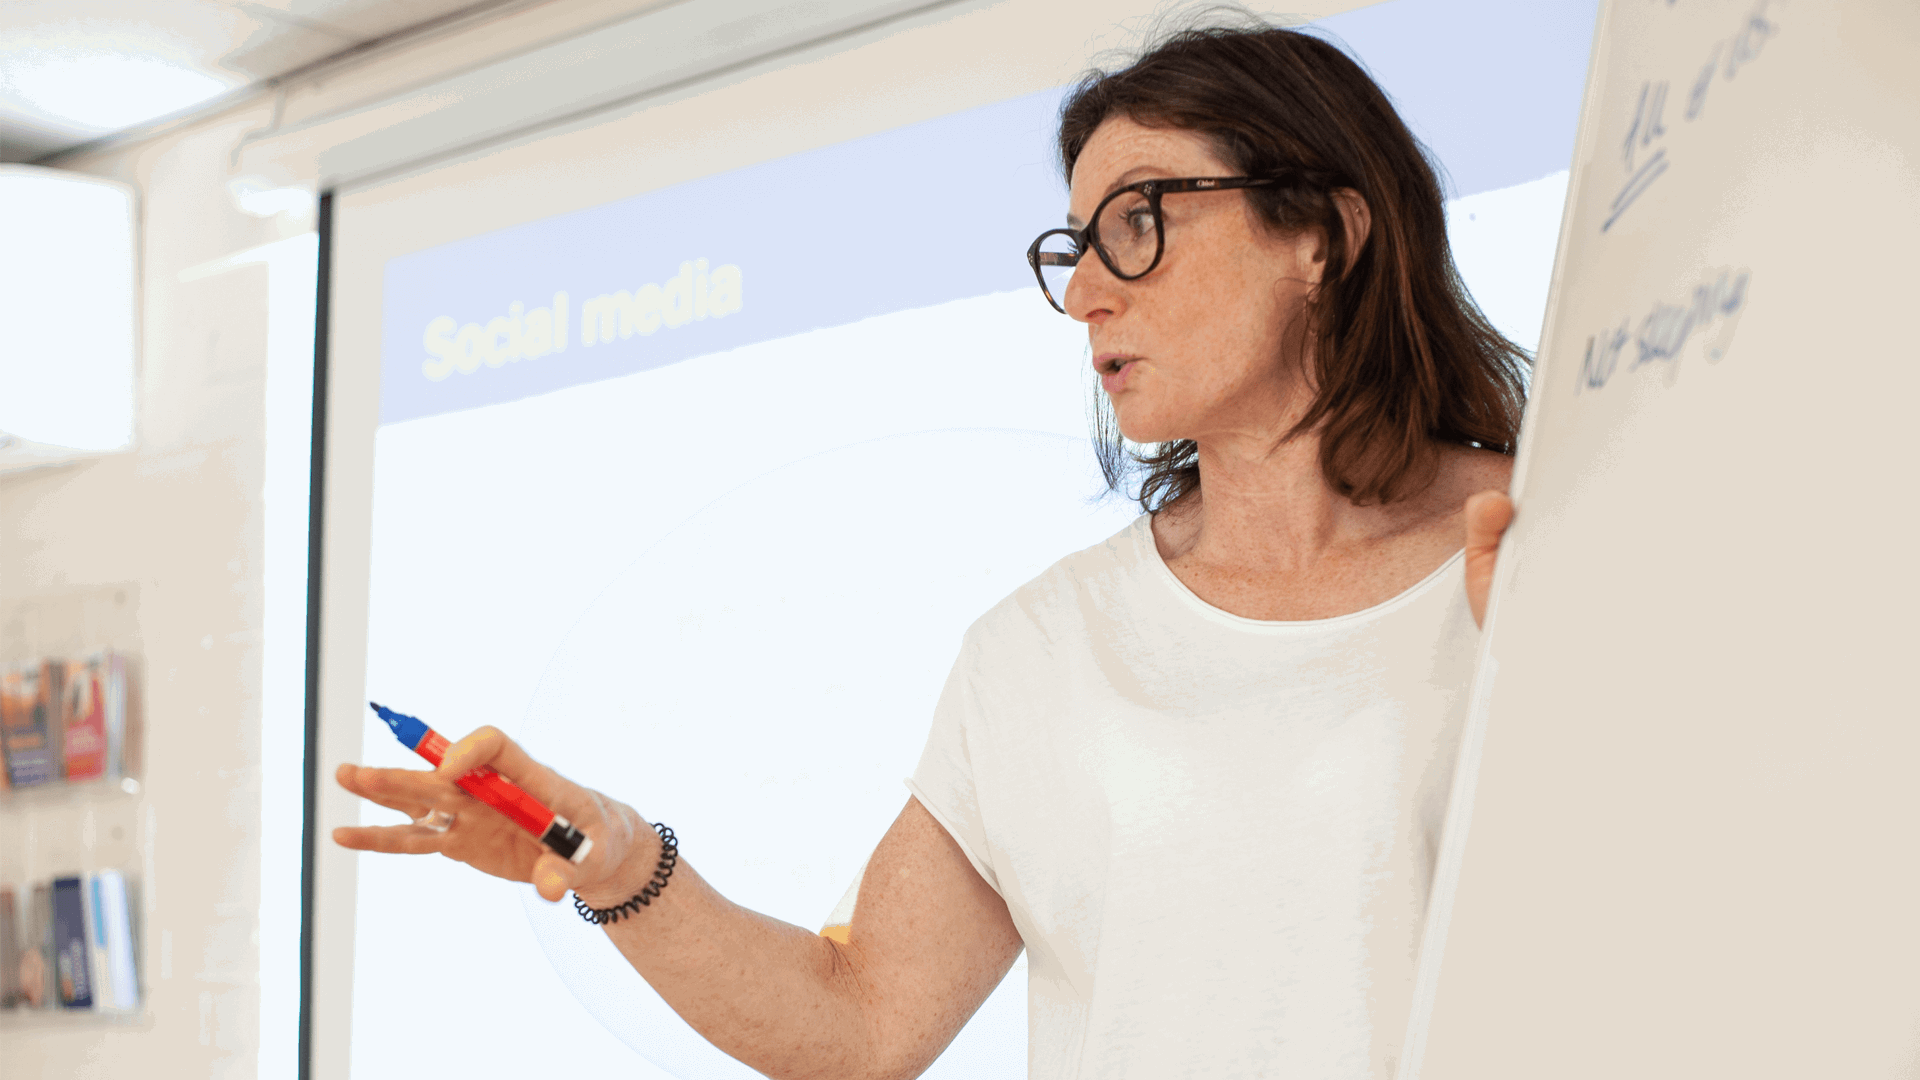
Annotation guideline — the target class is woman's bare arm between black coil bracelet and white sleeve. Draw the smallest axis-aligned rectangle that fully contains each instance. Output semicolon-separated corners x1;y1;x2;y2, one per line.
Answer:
582;799;1021;1080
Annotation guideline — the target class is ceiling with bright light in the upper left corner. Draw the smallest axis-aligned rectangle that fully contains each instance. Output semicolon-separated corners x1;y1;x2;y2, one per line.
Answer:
0;0;501;161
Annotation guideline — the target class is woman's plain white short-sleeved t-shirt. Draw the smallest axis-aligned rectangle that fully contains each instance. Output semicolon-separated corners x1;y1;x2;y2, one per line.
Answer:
908;515;1478;1080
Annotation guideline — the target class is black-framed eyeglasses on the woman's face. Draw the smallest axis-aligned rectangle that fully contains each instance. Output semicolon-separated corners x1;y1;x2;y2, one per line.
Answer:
1027;177;1283;315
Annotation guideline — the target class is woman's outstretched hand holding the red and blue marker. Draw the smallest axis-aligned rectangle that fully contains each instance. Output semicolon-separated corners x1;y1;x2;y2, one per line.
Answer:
334;726;653;903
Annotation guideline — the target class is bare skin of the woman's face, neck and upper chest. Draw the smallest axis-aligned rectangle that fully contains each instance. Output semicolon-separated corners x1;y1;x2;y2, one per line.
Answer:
1064;117;1511;619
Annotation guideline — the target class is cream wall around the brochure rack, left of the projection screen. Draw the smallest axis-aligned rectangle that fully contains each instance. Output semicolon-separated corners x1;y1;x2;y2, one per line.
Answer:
0;98;300;1078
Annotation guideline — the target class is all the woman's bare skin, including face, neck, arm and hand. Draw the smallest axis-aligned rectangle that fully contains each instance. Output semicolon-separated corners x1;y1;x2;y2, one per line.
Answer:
334;121;1507;1080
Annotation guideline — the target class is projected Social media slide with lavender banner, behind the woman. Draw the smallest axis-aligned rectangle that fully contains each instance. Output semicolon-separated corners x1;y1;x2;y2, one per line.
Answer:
351;0;1594;1080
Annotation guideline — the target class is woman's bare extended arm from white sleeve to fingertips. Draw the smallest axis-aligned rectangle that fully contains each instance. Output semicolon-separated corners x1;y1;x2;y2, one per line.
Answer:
334;728;1021;1080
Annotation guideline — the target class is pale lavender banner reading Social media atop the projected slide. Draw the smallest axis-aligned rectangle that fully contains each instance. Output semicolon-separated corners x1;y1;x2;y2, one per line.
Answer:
380;0;1596;423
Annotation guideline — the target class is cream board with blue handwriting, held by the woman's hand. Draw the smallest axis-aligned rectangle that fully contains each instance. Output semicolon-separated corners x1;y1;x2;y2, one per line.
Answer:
1400;0;1920;1080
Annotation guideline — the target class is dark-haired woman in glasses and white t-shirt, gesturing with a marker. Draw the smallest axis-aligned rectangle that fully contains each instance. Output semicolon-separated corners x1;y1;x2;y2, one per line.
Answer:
334;27;1524;1078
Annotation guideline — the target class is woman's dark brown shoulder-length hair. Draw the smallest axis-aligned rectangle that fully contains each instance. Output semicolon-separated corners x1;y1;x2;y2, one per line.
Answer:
1060;25;1532;511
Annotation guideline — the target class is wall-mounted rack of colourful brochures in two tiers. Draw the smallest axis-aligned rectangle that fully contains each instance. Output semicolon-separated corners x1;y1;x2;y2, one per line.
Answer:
0;586;148;1030
